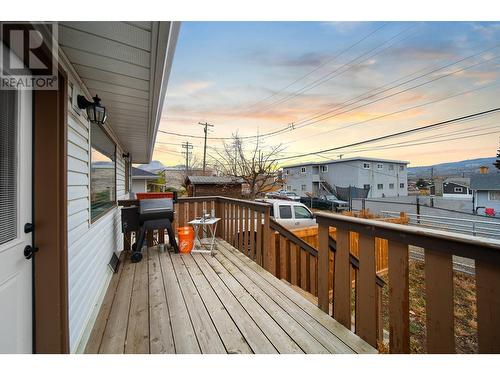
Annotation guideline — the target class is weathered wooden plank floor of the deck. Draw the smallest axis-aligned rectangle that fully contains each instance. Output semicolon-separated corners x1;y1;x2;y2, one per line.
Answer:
85;240;375;353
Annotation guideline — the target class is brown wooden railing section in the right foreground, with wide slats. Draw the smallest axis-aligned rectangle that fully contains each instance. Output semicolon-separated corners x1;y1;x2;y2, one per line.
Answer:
317;213;500;353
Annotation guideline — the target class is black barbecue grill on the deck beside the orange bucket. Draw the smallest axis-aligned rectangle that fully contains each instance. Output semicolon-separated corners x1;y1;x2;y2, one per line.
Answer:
122;198;179;263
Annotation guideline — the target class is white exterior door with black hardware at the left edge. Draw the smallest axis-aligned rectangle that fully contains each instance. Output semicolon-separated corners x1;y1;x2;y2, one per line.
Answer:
0;47;33;353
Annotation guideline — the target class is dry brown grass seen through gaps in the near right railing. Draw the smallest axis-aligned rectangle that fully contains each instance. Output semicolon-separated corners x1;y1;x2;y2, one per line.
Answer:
381;260;478;354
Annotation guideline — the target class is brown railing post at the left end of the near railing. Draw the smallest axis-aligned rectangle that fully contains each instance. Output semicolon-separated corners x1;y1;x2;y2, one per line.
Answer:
318;221;330;314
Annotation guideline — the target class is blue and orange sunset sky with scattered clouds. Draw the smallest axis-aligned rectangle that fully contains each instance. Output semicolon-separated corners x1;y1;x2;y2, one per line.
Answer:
153;22;500;166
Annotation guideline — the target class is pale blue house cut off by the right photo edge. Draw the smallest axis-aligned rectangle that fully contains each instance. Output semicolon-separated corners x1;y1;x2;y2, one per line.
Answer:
470;173;500;215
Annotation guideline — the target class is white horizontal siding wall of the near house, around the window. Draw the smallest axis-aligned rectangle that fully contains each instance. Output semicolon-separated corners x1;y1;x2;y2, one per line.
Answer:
67;64;125;352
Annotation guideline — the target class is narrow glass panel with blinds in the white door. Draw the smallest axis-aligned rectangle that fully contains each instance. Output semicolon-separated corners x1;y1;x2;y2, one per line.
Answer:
0;90;17;245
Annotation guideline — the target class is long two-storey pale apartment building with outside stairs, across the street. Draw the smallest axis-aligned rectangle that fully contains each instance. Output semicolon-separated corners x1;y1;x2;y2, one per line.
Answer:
283;157;408;198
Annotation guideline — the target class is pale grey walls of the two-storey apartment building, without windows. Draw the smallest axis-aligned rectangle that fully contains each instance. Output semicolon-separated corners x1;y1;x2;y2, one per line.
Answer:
284;160;408;198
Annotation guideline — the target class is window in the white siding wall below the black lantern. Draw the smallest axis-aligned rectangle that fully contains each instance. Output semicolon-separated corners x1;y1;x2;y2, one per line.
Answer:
90;123;116;222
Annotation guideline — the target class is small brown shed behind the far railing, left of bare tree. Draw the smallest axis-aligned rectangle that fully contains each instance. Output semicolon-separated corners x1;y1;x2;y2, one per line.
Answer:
186;176;243;198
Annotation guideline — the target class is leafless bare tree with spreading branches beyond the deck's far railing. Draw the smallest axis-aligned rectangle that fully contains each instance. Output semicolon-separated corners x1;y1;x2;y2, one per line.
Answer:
212;134;283;198
